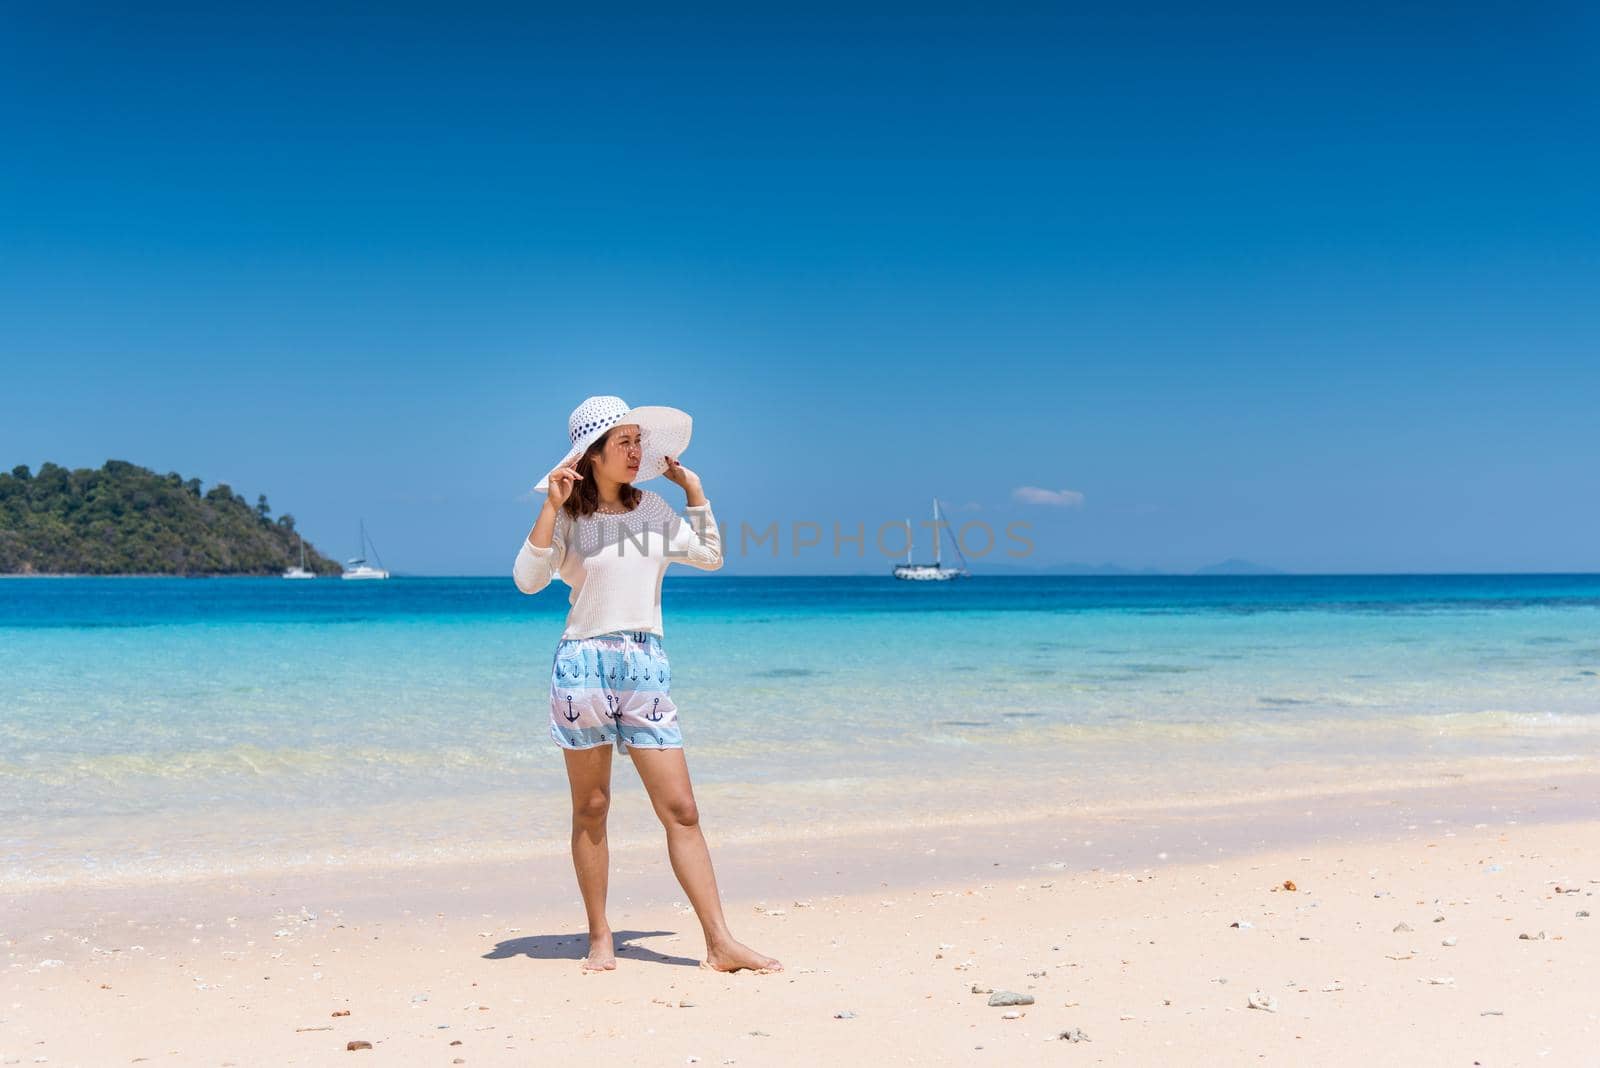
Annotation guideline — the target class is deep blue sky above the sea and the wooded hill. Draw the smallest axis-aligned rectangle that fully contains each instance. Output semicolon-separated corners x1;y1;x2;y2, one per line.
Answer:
0;3;1600;574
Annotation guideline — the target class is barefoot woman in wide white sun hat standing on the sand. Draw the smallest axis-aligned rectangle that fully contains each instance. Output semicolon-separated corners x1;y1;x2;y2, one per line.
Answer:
512;397;782;972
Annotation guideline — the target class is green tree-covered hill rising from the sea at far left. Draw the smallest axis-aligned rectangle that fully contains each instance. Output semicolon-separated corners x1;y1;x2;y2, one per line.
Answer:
0;460;339;576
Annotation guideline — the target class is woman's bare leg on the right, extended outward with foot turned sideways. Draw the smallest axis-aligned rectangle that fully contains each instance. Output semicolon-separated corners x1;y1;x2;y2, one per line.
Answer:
627;747;784;972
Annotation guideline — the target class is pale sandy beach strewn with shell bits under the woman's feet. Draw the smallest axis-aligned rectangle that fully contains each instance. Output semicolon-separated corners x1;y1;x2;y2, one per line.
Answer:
0;764;1600;1065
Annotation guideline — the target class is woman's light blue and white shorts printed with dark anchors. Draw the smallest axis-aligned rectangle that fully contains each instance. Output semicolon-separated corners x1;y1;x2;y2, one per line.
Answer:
550;630;683;753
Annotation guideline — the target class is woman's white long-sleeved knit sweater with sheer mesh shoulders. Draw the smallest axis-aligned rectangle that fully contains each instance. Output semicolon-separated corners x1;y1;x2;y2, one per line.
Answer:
512;489;722;638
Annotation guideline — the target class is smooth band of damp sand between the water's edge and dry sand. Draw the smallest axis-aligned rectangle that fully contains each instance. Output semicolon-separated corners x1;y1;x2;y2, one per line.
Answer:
0;767;1600;935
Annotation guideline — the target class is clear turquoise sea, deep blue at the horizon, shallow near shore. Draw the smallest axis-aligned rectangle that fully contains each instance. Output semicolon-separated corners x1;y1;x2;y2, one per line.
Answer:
0;576;1600;887
